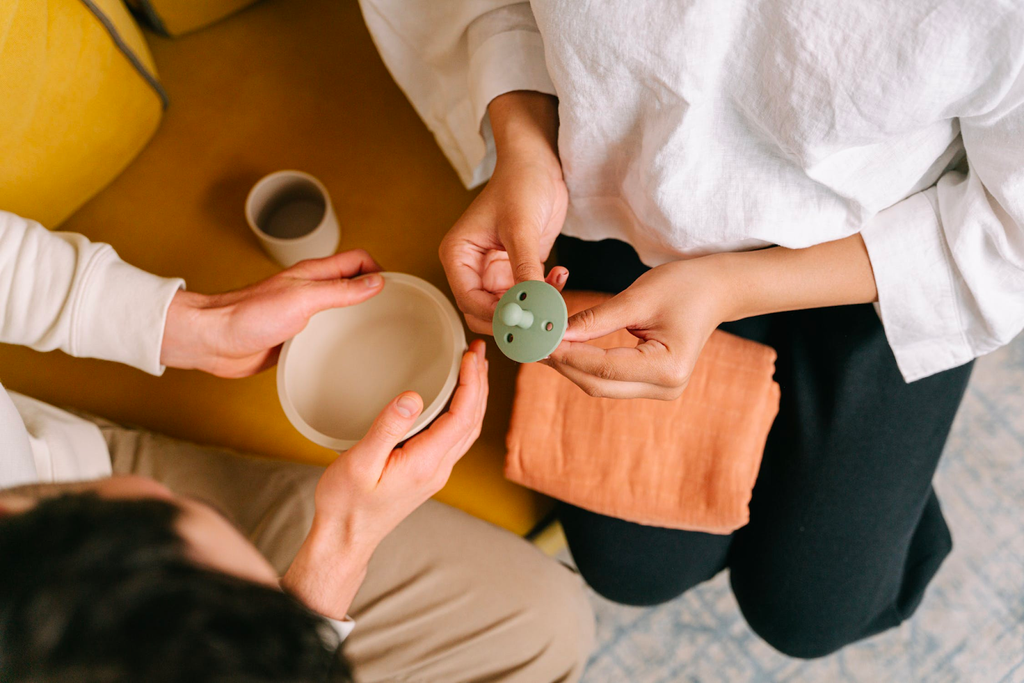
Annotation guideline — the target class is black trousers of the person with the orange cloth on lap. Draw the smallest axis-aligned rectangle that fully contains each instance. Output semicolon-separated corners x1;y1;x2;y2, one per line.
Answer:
557;237;971;657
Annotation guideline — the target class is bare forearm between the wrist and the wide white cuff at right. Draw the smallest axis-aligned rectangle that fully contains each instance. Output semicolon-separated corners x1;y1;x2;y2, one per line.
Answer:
700;234;878;321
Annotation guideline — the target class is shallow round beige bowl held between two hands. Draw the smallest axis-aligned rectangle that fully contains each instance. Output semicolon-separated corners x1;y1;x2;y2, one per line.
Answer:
278;272;467;451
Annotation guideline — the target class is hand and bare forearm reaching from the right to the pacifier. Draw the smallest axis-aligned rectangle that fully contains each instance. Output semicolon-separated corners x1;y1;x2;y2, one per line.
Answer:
545;234;878;399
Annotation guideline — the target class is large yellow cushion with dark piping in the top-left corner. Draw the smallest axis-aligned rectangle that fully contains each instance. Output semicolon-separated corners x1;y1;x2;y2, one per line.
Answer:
0;0;162;227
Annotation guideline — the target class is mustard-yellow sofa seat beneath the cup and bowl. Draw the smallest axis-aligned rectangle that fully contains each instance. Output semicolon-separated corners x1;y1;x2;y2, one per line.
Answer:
0;0;550;532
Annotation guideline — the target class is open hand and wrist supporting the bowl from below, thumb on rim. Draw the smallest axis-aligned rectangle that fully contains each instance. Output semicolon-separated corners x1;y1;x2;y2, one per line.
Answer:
282;340;487;620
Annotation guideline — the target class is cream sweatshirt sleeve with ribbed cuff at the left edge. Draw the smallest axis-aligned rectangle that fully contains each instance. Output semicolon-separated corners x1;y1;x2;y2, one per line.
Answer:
0;211;184;375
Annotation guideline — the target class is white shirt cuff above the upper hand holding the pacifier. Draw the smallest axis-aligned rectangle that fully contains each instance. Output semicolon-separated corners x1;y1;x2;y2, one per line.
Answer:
469;31;556;136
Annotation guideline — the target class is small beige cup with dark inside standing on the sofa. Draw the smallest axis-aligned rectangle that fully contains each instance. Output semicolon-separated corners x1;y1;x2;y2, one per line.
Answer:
246;171;341;268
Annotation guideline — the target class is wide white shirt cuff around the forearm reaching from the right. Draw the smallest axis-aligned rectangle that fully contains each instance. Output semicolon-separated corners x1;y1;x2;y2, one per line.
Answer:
860;188;975;382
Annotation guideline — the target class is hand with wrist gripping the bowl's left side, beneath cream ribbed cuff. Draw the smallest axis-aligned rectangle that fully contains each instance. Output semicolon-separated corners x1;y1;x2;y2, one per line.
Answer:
160;250;384;377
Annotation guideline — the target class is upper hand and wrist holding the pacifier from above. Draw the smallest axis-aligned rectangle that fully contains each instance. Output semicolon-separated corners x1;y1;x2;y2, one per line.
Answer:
440;92;568;334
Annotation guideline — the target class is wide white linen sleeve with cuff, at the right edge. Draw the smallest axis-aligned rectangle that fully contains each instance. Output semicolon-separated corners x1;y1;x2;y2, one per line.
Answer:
861;72;1024;382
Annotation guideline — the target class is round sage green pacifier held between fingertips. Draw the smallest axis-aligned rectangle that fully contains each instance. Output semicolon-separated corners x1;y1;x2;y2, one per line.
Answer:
492;280;569;362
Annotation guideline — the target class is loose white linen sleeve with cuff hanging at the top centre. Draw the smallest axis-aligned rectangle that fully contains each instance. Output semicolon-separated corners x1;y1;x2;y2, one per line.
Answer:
359;0;555;187
